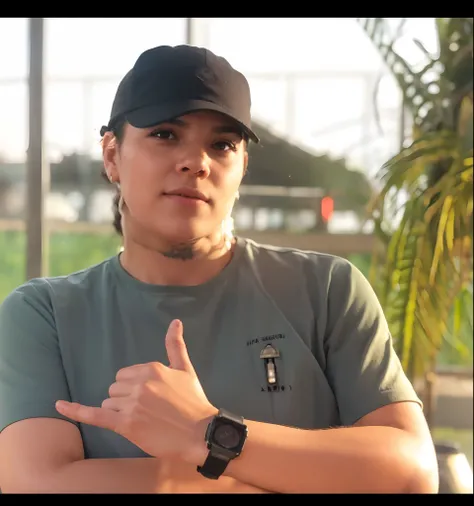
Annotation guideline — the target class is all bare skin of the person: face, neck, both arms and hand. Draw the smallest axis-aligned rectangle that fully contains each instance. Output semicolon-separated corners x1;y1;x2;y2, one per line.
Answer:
0;112;438;493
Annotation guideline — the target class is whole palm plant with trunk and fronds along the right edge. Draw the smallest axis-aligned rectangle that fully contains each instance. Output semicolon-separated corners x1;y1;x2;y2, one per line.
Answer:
357;18;473;416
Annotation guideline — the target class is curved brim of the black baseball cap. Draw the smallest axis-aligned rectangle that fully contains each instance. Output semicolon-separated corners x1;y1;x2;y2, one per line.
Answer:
125;100;260;143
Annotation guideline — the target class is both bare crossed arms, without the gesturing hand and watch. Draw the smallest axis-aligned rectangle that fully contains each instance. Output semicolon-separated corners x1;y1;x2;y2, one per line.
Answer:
0;402;438;493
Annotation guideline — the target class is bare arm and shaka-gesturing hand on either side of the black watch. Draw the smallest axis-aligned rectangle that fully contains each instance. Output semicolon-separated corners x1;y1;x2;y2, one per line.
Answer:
52;320;438;493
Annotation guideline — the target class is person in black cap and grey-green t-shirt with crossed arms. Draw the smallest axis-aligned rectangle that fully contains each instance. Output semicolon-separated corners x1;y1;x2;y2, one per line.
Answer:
0;46;437;493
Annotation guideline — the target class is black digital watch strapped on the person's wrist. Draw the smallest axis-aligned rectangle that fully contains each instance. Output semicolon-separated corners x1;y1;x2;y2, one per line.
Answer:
197;409;248;480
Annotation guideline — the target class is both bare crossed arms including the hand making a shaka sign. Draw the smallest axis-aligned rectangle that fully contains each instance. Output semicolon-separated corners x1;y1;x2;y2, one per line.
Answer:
0;322;438;493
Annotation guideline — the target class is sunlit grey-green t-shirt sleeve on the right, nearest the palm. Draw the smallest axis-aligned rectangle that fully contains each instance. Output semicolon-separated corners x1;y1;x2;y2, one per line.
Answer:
325;259;421;425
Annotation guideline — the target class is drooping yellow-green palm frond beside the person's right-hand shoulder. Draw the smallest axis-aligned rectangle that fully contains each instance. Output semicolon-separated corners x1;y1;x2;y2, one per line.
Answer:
372;132;473;377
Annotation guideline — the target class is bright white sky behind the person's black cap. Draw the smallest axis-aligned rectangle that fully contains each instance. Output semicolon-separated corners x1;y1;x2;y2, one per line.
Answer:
0;18;437;176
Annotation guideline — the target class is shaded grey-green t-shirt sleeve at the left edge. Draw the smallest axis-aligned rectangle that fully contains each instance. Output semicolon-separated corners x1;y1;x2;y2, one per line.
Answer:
0;281;77;431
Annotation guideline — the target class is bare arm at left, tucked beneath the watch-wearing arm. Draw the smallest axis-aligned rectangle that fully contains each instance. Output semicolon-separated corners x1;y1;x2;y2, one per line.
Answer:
0;418;266;494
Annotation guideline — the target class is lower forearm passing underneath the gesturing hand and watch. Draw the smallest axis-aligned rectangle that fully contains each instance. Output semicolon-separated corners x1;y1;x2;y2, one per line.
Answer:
31;458;264;494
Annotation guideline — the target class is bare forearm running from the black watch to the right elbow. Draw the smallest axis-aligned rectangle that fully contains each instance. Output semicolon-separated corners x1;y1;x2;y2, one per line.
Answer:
226;421;434;493
